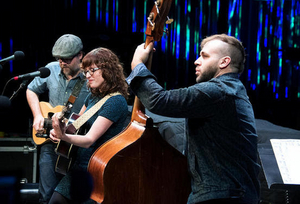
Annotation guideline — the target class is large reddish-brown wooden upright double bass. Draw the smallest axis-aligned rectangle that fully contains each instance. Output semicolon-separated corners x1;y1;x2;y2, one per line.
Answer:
88;0;190;204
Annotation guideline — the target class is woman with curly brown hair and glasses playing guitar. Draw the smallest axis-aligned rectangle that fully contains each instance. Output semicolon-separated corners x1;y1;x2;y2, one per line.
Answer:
49;48;128;203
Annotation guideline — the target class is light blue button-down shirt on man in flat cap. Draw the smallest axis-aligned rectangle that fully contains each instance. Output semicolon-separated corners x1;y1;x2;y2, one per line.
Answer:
27;62;89;113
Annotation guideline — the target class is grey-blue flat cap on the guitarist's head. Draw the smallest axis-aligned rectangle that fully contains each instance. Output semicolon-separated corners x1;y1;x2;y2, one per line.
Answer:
52;34;83;58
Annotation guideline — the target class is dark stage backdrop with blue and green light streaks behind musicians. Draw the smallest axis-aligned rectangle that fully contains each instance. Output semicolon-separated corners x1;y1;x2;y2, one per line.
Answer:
0;0;300;136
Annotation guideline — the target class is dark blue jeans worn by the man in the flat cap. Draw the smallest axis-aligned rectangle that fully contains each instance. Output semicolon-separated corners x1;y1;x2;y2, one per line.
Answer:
39;143;63;203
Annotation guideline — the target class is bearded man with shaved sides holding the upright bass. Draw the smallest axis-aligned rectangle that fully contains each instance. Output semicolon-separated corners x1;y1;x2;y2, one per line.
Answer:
127;34;260;204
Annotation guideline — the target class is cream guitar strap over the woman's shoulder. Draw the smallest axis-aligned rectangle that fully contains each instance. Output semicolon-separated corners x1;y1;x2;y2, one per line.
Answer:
72;92;121;130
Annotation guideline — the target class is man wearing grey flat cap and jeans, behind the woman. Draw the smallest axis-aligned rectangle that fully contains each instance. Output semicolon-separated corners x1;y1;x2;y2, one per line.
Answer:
26;34;88;203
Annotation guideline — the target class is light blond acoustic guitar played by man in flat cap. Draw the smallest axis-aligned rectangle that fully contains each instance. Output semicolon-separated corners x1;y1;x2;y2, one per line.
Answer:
32;101;68;145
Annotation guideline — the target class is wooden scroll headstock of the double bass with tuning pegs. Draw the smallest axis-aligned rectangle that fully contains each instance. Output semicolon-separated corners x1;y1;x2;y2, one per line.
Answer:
145;0;173;46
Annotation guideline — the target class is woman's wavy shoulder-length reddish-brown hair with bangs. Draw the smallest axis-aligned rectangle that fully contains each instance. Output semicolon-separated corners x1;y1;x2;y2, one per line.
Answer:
81;47;128;99
